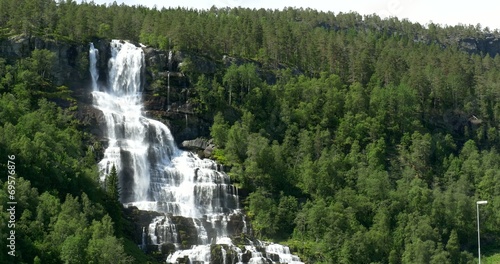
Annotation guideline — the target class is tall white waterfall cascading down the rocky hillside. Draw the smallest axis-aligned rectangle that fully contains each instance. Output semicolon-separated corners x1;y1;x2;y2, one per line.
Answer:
89;40;302;263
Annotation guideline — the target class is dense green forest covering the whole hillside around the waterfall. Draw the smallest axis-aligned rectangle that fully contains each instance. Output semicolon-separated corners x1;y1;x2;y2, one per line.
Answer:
0;0;500;263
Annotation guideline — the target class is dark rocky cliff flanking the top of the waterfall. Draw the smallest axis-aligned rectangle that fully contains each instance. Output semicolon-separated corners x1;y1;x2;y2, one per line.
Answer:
0;35;211;145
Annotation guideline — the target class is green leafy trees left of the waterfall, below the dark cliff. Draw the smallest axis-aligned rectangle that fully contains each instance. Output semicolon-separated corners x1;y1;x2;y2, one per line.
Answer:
0;29;137;263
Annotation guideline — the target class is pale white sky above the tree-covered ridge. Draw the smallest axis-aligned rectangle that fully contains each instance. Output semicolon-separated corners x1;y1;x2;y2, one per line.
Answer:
87;0;500;30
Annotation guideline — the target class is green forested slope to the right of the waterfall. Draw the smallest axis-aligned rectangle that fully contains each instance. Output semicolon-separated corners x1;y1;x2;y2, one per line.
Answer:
188;6;500;263
